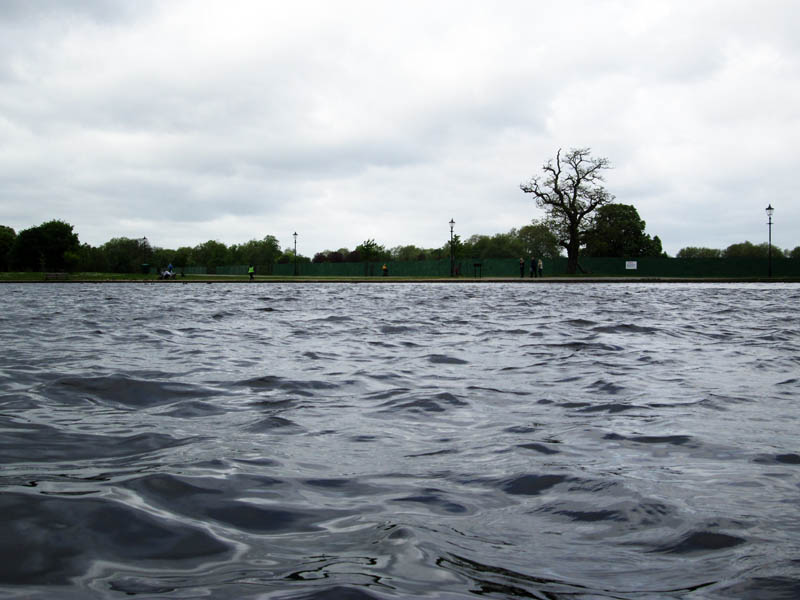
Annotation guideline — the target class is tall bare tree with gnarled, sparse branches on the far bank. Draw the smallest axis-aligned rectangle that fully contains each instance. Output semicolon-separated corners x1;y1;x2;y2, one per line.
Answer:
519;148;614;274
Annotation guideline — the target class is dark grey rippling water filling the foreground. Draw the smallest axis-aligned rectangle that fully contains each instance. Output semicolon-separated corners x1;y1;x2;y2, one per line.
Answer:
0;284;800;599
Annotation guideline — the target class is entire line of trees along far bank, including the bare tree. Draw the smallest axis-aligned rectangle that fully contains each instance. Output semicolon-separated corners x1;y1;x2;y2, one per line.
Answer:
0;148;800;273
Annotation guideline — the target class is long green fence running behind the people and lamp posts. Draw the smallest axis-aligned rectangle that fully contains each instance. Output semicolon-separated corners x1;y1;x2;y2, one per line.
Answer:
151;257;800;278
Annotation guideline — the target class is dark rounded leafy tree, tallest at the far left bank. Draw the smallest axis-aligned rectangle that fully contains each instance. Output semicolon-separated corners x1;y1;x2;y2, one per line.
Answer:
11;220;80;271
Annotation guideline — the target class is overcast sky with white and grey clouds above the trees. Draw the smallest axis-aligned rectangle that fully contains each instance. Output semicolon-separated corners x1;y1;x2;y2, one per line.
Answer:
0;0;800;255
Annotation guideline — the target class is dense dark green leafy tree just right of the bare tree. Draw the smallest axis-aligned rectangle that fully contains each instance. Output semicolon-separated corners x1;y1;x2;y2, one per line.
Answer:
585;204;663;258
